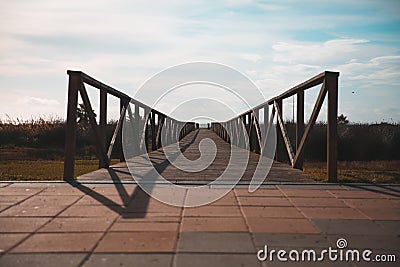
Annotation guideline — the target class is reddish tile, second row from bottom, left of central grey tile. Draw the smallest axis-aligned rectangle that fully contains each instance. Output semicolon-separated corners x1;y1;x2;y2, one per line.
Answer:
95;231;177;253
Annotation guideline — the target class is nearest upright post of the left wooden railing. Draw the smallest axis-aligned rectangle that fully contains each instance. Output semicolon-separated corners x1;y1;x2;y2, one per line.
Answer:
64;73;82;180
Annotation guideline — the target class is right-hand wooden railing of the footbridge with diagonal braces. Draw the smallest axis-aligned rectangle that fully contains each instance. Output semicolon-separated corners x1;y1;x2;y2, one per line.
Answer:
211;71;339;182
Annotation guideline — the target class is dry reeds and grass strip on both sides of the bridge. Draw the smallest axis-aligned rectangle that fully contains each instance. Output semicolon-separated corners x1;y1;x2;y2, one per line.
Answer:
0;118;400;183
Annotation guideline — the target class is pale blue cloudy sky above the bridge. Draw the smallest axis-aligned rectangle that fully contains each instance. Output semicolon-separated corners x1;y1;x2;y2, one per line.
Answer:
0;0;400;123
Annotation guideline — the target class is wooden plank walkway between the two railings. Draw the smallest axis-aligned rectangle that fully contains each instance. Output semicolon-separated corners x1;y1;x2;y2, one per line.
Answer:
78;129;314;183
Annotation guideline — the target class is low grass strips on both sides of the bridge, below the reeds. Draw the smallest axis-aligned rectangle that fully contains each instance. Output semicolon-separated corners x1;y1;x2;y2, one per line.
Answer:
0;159;400;184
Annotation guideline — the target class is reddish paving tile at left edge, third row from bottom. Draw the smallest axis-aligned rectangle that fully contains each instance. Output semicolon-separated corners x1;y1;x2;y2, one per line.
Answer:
0;217;50;233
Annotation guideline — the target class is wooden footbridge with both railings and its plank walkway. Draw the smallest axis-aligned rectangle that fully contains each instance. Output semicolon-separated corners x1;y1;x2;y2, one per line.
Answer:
64;71;339;183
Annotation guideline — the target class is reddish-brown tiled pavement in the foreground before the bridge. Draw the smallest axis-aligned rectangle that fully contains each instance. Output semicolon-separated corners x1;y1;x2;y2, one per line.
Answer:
0;182;400;267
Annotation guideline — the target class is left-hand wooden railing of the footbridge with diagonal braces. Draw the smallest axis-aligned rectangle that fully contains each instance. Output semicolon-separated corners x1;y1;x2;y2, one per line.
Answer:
64;70;196;180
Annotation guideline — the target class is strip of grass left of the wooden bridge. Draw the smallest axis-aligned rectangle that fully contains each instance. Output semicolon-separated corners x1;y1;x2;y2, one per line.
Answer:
0;159;119;181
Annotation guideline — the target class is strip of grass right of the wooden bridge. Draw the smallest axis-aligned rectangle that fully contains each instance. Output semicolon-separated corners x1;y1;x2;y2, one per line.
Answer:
304;160;400;184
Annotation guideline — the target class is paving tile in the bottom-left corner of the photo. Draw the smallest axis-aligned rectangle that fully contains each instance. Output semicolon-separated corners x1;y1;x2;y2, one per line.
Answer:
0;253;86;267
